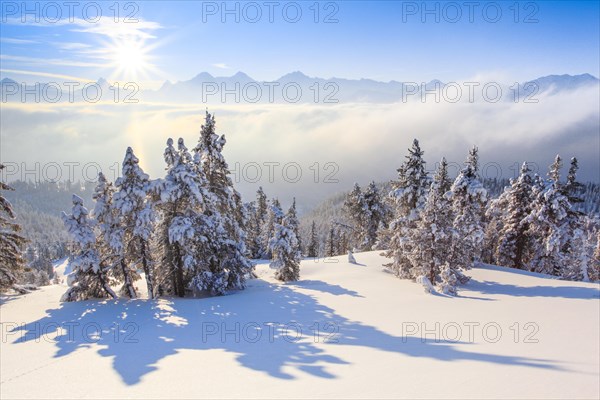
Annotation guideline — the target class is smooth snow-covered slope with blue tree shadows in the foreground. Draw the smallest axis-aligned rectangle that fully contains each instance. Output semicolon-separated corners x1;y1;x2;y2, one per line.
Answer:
0;252;600;399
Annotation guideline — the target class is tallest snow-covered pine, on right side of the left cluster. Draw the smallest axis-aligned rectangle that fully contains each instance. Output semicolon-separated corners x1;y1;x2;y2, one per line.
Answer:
194;111;254;294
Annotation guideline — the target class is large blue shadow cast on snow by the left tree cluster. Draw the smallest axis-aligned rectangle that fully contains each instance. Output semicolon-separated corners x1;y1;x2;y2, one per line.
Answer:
8;280;560;385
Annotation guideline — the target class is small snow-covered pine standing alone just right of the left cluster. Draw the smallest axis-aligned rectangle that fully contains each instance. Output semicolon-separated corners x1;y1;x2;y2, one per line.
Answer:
269;216;300;282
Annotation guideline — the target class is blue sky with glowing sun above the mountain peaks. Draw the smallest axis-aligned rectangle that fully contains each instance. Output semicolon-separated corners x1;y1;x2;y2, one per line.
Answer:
0;1;600;84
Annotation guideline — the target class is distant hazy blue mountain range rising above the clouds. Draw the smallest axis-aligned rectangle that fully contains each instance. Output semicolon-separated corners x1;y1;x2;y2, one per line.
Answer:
0;71;600;104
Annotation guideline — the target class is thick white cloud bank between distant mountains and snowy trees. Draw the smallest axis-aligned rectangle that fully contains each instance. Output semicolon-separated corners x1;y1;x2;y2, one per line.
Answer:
2;88;600;209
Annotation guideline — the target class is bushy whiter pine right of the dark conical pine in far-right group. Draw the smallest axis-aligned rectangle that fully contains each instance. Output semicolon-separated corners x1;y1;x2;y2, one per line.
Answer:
527;155;571;276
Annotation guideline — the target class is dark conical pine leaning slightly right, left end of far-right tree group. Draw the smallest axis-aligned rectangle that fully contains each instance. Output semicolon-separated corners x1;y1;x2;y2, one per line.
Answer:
495;162;533;269
